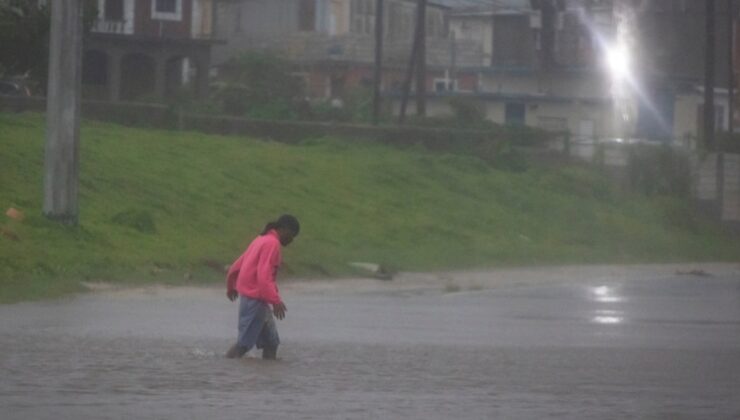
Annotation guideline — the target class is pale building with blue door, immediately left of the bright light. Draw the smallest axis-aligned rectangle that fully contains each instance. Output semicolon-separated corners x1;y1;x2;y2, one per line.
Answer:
408;0;622;140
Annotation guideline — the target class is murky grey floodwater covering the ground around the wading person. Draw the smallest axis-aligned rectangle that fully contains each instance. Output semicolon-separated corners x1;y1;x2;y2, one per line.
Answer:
0;265;740;419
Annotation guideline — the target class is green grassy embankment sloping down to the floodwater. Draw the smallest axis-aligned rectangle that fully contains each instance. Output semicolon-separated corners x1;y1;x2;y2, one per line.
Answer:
0;114;740;302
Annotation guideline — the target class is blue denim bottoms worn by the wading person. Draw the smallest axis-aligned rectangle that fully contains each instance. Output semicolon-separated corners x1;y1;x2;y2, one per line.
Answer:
236;295;280;353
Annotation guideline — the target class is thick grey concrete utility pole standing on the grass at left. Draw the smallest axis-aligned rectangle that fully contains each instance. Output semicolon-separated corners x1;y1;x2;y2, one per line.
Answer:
43;0;83;225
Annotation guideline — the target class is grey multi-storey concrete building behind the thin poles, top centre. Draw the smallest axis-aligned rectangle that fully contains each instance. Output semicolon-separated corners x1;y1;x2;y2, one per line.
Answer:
214;0;481;98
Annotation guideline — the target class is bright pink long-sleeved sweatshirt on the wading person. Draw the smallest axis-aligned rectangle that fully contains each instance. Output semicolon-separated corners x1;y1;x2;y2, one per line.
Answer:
226;229;282;305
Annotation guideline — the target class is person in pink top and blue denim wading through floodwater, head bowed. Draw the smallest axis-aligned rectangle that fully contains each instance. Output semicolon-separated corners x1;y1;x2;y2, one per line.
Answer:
226;214;301;359
